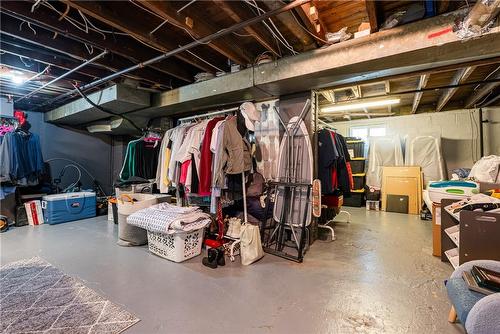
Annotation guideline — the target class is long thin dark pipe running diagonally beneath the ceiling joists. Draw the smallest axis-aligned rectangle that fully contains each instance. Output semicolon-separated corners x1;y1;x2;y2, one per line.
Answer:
39;0;311;108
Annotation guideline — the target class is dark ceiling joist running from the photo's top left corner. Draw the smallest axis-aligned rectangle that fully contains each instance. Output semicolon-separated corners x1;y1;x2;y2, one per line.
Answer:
0;1;194;84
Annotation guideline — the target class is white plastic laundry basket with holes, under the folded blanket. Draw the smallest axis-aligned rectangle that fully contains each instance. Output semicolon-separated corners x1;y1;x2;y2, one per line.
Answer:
148;227;205;262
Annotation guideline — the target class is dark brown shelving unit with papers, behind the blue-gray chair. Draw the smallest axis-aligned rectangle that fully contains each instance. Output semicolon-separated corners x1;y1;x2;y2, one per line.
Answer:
441;199;500;268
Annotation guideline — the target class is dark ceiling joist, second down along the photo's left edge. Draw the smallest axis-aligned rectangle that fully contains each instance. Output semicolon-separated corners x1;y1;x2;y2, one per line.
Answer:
1;15;175;86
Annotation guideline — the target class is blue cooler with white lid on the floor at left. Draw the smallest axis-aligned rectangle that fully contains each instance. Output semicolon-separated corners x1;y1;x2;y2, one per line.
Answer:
42;191;96;225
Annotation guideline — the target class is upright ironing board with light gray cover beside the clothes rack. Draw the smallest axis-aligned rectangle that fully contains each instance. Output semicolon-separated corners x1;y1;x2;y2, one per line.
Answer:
273;116;313;226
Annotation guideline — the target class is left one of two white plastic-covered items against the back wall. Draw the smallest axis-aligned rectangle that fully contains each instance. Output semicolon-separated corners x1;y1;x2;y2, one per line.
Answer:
366;135;404;189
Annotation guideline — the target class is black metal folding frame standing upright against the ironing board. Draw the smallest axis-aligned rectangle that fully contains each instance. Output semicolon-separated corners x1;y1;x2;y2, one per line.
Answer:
261;99;312;262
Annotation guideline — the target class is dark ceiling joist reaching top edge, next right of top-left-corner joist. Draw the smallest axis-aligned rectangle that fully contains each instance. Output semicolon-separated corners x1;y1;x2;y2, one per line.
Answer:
62;0;219;72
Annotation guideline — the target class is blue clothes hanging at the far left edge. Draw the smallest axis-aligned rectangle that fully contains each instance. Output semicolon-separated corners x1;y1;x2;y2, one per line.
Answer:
0;130;43;186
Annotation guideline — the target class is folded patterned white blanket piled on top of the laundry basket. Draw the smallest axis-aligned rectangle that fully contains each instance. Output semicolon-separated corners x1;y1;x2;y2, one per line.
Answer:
127;203;212;234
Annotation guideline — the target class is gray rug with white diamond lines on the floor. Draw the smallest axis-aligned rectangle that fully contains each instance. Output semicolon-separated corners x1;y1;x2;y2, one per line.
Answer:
0;257;139;334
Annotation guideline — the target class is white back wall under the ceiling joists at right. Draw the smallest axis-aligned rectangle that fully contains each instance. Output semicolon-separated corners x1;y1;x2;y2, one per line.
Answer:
334;108;500;177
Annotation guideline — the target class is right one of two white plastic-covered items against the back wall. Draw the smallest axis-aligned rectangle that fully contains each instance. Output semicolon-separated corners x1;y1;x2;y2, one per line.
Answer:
405;135;446;185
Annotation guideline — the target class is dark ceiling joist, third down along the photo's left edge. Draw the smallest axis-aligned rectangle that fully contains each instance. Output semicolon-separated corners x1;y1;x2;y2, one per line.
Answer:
0;38;111;81
